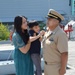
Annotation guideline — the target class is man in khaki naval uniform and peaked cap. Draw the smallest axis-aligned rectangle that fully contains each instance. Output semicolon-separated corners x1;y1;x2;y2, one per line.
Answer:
43;9;68;75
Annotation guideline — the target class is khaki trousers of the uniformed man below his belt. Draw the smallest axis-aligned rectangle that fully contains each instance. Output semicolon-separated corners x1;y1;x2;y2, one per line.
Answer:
44;64;60;75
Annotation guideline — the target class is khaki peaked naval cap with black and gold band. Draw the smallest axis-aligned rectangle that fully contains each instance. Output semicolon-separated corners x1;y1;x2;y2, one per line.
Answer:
46;9;64;22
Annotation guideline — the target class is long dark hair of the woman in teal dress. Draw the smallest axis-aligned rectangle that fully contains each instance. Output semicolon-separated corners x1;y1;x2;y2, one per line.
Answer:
14;16;29;44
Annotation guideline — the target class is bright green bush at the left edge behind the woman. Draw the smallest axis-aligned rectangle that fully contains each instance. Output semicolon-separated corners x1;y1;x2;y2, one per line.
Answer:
0;23;9;41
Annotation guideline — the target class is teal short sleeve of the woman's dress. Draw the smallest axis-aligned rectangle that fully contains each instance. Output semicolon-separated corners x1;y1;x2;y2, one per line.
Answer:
13;34;25;48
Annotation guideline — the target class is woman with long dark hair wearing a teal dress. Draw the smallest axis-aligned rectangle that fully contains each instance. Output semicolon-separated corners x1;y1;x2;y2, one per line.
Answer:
12;16;34;75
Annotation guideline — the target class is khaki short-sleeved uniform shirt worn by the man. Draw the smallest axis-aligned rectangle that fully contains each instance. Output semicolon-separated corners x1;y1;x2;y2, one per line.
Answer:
43;26;68;63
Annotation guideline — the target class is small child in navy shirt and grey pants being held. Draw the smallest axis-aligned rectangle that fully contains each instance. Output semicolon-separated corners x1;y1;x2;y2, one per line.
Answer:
28;21;44;75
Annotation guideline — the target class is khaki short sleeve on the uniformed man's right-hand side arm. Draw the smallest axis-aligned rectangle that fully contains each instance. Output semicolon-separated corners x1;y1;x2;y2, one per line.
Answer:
57;33;68;53
